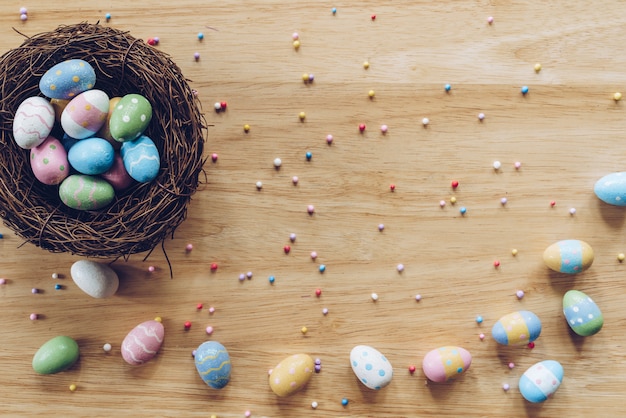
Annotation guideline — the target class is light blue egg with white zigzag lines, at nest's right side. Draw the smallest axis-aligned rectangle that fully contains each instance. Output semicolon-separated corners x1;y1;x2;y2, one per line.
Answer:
120;135;161;183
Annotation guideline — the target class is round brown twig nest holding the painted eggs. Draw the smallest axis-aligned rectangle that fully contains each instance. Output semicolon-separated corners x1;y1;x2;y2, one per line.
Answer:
0;23;206;258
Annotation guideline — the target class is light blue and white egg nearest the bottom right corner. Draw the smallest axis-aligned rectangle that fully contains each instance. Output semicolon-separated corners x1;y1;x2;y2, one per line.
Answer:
519;360;563;403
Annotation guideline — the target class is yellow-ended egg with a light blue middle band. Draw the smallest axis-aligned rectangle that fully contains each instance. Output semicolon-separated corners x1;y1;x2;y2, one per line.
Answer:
543;239;593;274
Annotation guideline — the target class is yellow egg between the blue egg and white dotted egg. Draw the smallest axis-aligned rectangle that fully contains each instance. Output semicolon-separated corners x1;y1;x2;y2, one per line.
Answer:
269;354;315;396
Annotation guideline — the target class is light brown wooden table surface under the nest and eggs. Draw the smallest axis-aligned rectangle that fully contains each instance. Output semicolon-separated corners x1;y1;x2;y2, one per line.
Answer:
0;0;626;417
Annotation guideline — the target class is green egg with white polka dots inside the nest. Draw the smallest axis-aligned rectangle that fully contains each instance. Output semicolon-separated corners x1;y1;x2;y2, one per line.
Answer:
109;94;152;142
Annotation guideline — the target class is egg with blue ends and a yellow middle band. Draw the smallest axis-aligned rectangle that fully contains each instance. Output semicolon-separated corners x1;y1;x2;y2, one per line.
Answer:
491;311;541;345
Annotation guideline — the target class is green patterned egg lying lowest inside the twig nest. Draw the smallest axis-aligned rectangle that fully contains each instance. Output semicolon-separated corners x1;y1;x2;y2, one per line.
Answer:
59;174;115;210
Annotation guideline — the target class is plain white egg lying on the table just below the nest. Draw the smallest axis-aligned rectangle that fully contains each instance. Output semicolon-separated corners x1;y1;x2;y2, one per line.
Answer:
70;260;120;298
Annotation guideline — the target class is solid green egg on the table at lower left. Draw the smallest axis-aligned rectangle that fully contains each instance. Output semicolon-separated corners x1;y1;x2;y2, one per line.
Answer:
33;335;79;374
